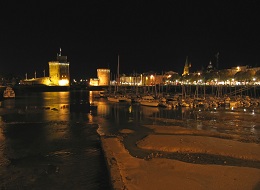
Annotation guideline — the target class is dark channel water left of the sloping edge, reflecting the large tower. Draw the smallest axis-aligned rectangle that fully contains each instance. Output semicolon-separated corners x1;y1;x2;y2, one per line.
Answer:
0;92;110;189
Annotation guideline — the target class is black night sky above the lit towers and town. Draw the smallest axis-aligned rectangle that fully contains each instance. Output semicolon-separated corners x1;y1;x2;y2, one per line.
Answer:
0;0;260;78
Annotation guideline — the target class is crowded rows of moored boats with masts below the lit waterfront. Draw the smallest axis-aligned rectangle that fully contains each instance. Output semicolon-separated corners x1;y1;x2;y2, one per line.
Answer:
102;85;260;108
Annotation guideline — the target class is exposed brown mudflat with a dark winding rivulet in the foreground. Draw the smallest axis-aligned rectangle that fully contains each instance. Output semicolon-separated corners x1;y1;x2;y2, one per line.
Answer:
101;125;260;190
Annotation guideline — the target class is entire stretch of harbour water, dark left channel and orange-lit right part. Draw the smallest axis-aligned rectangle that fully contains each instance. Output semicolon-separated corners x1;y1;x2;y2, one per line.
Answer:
0;90;260;189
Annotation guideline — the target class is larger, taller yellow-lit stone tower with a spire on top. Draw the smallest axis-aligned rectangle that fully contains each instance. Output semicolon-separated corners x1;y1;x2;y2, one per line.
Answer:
49;48;70;86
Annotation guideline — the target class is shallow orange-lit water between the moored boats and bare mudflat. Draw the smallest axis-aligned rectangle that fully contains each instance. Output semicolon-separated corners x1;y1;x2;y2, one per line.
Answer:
88;92;260;141
